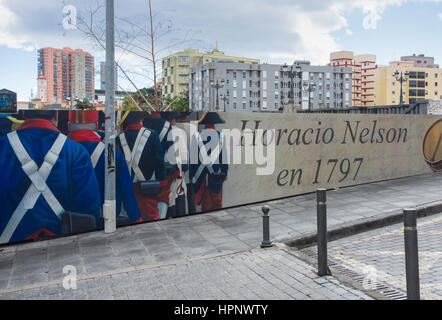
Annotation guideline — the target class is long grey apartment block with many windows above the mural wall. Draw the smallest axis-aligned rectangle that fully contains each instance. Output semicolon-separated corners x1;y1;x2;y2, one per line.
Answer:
189;61;352;112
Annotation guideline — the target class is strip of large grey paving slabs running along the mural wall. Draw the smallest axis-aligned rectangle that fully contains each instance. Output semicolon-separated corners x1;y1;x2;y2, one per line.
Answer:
0;173;442;296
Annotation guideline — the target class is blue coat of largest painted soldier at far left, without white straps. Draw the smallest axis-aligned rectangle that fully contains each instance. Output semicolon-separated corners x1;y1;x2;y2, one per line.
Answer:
0;120;101;242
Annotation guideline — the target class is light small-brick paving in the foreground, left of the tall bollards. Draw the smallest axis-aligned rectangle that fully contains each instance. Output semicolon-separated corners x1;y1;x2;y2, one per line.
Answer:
0;248;371;300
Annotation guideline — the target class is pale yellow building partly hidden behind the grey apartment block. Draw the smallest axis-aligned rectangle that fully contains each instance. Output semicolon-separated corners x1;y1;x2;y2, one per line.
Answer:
162;44;260;98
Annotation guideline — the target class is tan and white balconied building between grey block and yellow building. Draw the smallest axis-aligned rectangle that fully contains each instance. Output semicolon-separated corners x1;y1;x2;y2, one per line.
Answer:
330;51;378;107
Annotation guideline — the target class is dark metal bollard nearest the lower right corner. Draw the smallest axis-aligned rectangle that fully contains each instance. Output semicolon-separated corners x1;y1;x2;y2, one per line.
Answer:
404;209;420;300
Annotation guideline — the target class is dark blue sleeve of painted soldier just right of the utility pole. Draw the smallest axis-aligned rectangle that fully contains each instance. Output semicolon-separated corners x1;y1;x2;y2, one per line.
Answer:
116;149;141;222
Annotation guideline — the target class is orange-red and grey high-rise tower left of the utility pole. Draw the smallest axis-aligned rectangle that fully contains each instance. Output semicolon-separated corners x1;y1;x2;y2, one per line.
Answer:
37;48;95;103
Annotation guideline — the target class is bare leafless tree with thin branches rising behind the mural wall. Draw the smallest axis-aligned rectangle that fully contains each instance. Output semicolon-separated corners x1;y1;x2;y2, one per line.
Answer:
77;0;197;111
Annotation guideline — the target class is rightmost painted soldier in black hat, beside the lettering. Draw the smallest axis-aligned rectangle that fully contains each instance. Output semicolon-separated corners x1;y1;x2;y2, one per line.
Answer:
190;112;229;212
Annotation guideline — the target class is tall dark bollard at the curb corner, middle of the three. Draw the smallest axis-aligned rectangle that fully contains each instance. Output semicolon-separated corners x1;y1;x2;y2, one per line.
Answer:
316;189;330;277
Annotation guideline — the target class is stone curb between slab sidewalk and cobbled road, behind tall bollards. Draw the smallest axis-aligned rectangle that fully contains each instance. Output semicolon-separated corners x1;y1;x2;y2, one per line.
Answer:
284;201;442;249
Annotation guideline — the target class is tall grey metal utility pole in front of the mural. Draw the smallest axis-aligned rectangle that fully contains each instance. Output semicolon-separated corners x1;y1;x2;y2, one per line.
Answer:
103;0;117;233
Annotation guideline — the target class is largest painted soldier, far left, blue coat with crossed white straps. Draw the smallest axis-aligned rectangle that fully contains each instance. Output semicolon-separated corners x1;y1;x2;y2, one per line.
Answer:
0;110;101;243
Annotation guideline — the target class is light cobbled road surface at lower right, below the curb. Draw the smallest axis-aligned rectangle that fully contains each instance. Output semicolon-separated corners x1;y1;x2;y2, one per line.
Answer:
316;214;442;300
